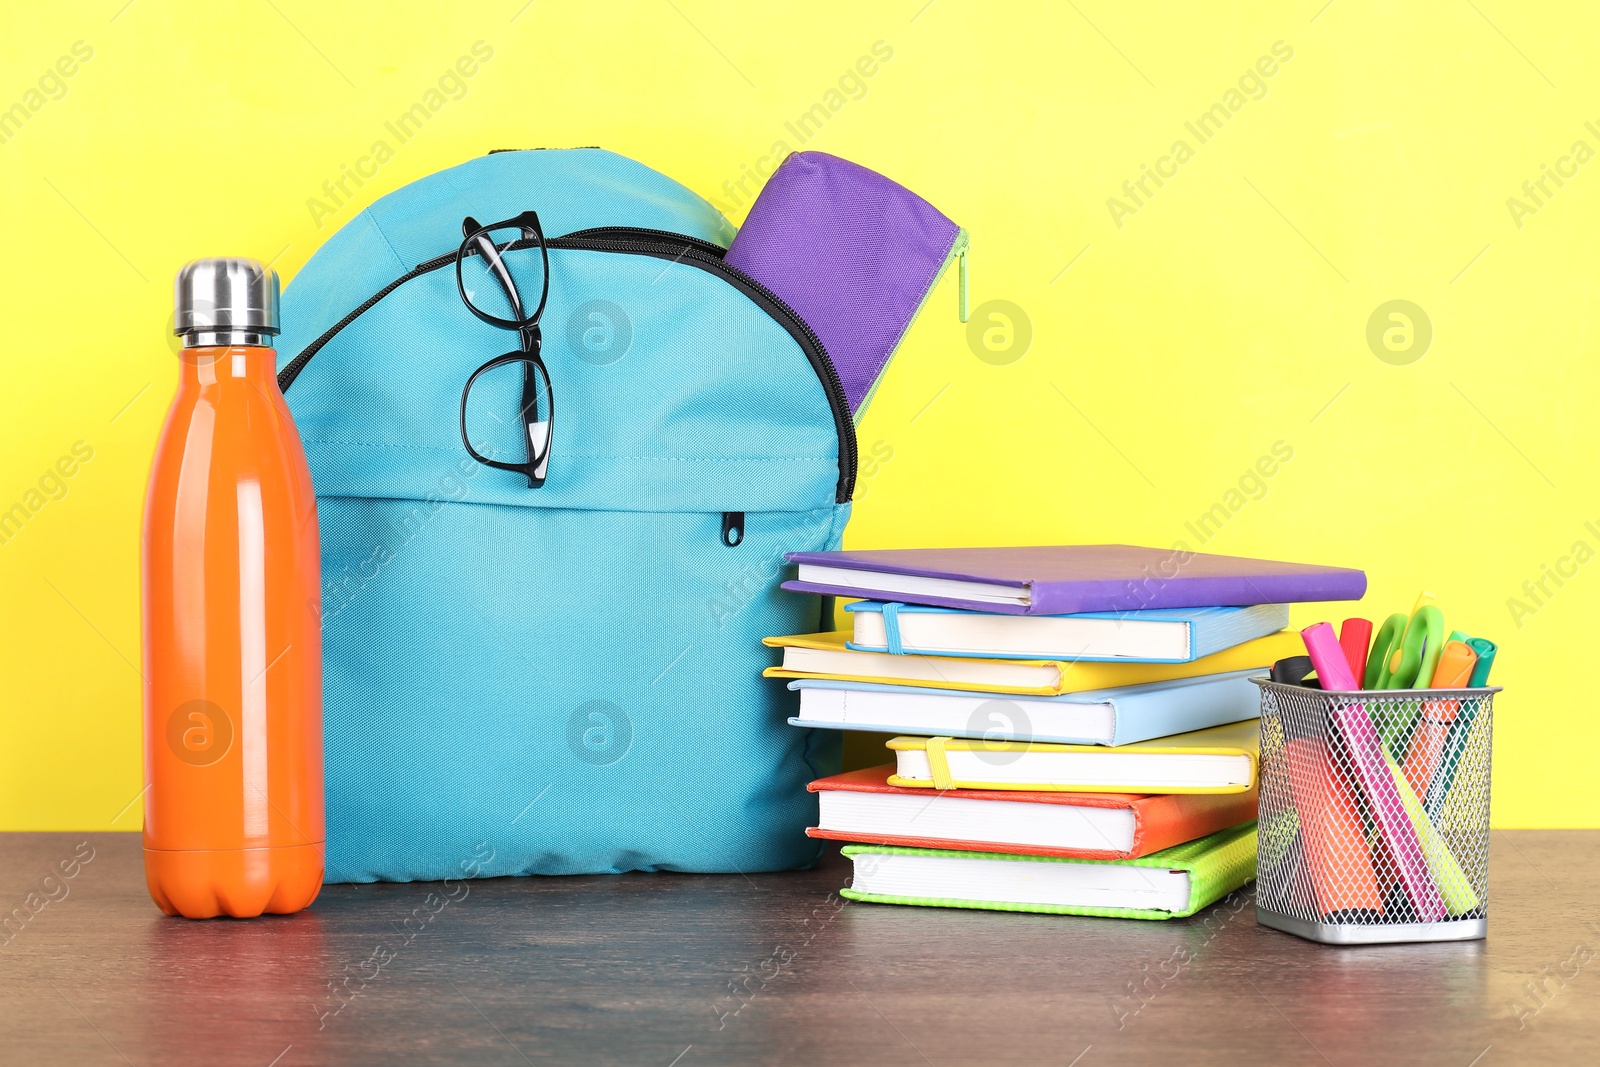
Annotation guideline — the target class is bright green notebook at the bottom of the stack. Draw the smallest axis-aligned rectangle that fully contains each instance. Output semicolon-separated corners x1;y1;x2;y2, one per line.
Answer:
840;822;1256;918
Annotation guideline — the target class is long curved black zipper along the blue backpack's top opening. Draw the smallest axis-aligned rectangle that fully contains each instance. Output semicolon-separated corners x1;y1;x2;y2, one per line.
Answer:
278;226;856;504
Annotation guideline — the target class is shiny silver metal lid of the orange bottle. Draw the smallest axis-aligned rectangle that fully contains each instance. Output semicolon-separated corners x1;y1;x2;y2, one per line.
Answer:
173;256;278;349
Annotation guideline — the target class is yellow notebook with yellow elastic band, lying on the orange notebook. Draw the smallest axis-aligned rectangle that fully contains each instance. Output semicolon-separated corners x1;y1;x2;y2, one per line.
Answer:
888;718;1261;793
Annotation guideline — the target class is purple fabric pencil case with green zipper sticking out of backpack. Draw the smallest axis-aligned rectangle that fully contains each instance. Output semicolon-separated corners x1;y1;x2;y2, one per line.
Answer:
725;152;968;419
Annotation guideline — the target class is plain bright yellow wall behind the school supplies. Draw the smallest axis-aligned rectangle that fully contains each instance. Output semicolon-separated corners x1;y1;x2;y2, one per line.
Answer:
0;0;1600;829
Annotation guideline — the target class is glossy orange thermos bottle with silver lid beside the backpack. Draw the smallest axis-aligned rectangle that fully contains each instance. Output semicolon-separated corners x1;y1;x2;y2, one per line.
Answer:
144;259;325;918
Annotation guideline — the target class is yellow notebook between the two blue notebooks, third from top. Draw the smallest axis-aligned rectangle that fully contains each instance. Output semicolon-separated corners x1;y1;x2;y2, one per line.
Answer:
762;630;1306;696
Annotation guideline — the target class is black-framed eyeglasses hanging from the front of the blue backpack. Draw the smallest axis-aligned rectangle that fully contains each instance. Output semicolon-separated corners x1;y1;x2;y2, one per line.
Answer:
456;211;555;490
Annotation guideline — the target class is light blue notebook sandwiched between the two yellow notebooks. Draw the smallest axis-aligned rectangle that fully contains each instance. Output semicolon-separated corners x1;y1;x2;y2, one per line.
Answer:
789;670;1266;748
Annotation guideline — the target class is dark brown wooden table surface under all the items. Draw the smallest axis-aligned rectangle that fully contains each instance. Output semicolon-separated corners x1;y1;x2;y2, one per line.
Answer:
0;830;1600;1067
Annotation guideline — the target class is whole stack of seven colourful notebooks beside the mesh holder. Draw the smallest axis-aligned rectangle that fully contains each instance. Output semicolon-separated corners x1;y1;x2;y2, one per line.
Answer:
766;545;1366;918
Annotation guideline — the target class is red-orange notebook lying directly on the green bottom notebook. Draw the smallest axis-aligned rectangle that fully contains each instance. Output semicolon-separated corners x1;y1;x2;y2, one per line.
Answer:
806;765;1256;859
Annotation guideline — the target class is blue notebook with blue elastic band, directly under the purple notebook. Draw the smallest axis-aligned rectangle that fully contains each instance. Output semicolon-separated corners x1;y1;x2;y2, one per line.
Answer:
845;600;1290;664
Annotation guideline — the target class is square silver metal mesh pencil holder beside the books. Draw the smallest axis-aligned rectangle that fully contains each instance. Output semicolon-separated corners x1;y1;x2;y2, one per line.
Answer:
1256;680;1499;945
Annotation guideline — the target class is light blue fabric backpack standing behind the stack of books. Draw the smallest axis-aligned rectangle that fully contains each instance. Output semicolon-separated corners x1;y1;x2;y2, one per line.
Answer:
278;149;856;881
